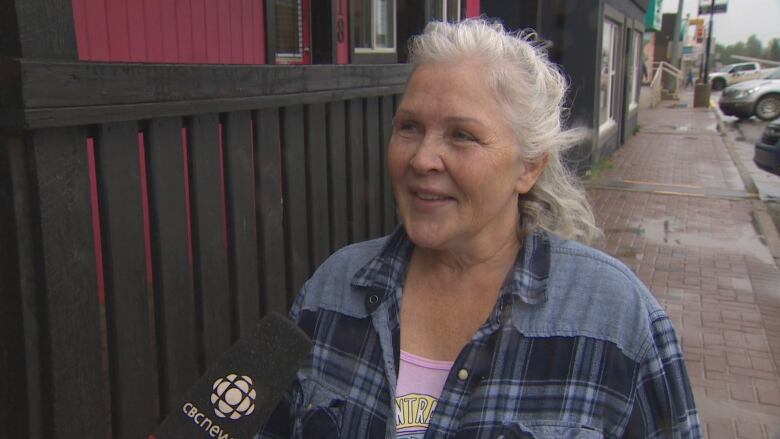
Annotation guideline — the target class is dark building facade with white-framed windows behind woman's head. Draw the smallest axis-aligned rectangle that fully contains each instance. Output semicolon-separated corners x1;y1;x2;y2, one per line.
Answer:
481;0;647;172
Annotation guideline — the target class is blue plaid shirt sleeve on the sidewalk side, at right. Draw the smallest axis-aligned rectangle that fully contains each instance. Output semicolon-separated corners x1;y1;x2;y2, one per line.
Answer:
624;311;702;438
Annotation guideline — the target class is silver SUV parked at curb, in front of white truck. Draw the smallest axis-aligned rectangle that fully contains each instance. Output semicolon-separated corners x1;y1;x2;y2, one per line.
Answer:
718;68;780;120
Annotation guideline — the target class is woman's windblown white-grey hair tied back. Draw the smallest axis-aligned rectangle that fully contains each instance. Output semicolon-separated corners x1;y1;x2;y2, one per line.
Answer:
409;18;601;242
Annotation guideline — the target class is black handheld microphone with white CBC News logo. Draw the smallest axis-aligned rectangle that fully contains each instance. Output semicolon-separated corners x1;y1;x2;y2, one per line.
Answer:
149;313;312;439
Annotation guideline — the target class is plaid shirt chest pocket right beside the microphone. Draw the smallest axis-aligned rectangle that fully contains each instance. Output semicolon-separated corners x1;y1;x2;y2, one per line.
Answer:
295;379;346;439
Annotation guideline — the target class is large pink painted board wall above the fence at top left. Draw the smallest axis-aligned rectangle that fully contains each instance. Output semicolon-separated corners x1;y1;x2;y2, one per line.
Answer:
72;0;266;64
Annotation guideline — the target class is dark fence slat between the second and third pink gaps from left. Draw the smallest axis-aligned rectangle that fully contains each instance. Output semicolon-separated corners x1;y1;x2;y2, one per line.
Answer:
147;118;199;420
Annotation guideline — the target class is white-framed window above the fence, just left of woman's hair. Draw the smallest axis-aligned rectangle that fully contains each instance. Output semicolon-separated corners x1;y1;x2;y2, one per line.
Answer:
353;0;395;53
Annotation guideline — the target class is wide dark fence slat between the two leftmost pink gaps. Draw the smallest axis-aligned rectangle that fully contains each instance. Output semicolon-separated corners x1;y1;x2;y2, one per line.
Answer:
95;122;157;438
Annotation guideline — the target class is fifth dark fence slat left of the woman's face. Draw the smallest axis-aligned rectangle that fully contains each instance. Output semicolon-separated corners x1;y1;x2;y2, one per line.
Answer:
306;104;330;267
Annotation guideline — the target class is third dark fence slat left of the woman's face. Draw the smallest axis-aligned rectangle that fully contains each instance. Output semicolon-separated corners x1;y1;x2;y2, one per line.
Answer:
347;99;368;242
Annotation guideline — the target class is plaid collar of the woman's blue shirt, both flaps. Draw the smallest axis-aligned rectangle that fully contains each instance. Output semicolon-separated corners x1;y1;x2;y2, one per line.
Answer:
352;225;550;312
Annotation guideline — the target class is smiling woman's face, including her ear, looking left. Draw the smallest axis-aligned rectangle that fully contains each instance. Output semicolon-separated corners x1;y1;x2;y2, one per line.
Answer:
388;62;542;250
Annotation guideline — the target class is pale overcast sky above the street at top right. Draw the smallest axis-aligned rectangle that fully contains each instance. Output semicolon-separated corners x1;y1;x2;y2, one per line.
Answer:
663;0;780;47
